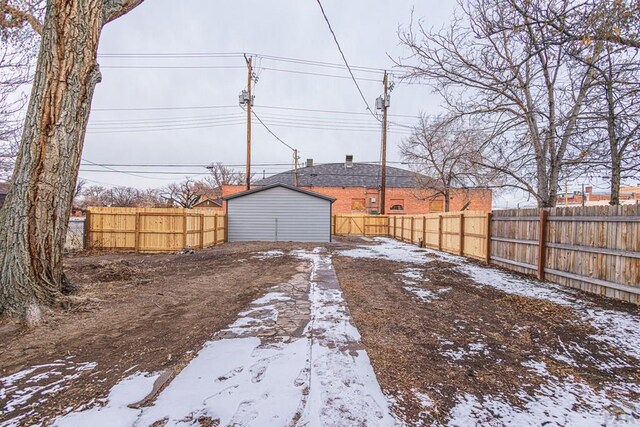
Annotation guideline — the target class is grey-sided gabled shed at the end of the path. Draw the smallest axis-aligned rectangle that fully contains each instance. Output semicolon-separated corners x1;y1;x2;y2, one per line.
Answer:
224;184;335;242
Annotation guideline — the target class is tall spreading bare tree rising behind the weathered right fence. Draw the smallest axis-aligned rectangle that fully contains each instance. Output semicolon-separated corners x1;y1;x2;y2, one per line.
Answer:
399;0;602;207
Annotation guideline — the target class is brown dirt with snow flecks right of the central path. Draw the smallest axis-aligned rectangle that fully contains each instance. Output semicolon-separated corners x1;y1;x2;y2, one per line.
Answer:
333;255;640;425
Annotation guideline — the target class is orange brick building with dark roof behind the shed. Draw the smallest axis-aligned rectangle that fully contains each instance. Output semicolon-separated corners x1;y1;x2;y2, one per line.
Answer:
223;160;492;215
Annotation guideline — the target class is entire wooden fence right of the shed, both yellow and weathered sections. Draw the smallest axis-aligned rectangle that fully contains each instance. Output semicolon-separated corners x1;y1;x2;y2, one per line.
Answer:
333;205;640;304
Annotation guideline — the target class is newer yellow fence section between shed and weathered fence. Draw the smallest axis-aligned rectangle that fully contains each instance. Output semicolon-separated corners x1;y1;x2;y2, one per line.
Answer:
333;211;491;261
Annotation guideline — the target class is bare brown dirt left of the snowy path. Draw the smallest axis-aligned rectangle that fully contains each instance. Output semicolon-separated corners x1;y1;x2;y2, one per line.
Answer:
0;243;317;426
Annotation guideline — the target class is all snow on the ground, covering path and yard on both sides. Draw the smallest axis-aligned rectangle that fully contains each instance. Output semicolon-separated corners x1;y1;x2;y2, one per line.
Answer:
6;238;640;427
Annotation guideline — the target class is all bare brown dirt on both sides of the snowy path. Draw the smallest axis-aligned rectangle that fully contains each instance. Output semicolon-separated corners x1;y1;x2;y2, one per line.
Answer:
0;238;640;425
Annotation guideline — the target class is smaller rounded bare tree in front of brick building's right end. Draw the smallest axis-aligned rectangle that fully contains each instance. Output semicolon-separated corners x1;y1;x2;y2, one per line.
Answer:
400;115;498;212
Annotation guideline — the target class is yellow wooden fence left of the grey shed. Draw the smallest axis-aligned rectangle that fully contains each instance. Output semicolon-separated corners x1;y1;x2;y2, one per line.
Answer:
85;207;226;252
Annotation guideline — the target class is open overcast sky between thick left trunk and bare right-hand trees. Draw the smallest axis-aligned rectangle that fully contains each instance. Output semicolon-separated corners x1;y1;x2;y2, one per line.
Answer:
80;0;524;207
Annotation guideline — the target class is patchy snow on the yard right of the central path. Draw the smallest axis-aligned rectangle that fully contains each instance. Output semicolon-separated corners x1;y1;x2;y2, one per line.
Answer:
340;238;640;426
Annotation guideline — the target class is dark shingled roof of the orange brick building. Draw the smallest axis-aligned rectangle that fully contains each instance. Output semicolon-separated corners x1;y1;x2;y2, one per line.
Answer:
255;163;426;188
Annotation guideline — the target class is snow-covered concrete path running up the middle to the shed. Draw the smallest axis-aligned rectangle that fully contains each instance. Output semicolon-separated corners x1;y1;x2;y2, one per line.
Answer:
55;249;397;427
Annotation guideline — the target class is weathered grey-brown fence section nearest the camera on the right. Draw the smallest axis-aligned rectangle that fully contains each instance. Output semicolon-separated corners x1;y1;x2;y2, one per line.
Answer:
491;205;640;304
